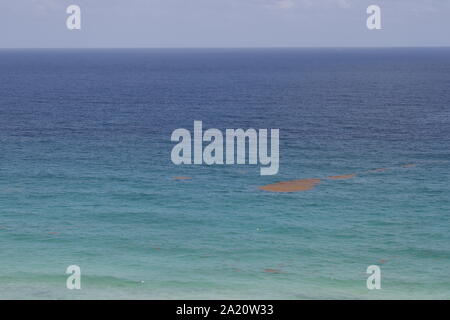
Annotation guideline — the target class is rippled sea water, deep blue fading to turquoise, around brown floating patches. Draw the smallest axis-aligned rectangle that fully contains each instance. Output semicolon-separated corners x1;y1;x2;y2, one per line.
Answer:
0;49;450;299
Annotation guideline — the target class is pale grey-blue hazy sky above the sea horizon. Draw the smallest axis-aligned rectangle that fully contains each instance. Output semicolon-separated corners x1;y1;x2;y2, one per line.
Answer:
0;0;450;48
